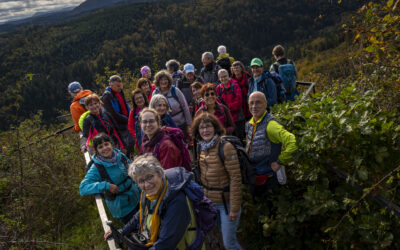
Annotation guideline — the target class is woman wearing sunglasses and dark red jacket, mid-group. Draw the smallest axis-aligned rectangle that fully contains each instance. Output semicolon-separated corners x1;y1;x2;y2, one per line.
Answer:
195;83;235;135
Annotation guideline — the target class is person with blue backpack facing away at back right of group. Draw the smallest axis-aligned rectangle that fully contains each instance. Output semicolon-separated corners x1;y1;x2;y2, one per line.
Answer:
269;45;299;101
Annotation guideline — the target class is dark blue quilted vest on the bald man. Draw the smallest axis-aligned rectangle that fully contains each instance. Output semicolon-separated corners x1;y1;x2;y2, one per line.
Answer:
246;113;282;176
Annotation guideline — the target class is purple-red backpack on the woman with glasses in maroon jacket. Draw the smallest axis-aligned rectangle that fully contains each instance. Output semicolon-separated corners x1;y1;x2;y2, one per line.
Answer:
154;127;191;171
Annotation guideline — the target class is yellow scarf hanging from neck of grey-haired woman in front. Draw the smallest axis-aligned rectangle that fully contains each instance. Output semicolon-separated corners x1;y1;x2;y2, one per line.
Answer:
139;181;167;247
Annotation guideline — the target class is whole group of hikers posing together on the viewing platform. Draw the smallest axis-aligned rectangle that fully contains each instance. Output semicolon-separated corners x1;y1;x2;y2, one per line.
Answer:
72;45;298;249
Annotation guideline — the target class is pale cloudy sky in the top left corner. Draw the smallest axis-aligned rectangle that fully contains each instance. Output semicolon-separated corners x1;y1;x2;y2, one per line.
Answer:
0;0;85;24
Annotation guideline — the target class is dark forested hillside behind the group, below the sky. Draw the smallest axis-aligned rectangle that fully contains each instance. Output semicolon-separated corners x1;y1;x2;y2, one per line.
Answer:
0;0;362;129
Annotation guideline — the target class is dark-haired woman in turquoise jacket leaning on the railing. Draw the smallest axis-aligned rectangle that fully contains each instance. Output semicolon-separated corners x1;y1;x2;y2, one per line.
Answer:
79;133;140;224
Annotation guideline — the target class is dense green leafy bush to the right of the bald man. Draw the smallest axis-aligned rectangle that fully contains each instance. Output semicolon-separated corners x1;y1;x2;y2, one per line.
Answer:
239;84;400;249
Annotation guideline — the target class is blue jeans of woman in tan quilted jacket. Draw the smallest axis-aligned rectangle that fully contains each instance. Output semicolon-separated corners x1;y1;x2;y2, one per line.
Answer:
213;203;242;250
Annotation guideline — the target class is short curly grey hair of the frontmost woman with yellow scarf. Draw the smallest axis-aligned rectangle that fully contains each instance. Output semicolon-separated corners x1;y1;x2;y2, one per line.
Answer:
128;153;165;182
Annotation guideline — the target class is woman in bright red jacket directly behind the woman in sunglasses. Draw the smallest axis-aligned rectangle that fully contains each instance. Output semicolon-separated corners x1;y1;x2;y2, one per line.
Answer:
216;69;245;140
